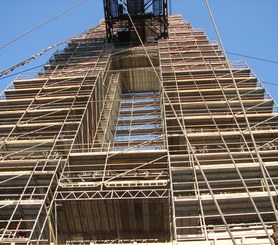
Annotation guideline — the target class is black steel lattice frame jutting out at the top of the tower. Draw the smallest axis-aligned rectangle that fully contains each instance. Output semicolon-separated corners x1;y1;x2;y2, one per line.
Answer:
103;0;168;42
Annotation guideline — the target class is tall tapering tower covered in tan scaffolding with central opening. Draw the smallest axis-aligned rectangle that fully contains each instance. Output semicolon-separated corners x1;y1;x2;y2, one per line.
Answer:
0;12;278;245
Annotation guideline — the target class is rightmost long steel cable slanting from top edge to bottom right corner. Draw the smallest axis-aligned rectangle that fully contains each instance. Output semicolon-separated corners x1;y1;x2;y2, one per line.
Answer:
205;0;278;244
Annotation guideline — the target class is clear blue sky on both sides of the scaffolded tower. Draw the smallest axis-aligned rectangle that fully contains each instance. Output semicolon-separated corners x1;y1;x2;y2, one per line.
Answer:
0;0;278;101
